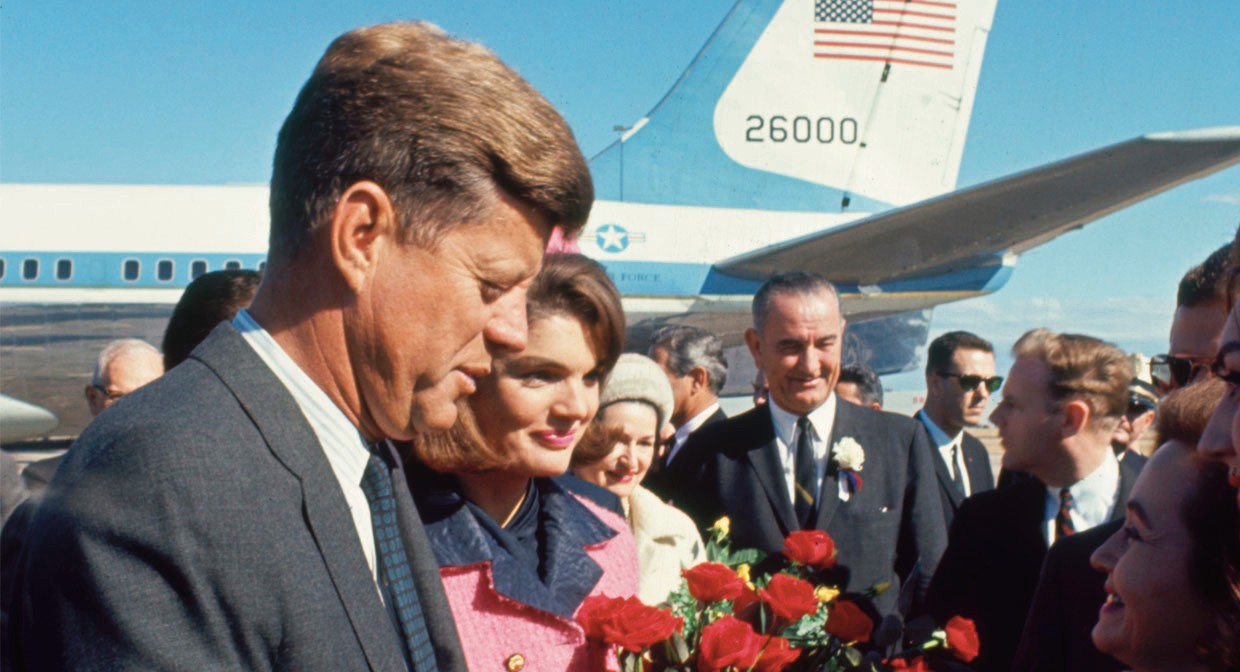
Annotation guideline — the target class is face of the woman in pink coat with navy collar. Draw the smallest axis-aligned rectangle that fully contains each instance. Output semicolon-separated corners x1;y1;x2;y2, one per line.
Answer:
470;314;601;477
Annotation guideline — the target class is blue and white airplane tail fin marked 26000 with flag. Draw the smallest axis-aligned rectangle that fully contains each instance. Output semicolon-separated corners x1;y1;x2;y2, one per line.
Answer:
591;0;996;212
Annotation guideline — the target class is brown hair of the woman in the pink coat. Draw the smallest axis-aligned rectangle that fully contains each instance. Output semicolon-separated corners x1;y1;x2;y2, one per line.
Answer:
413;254;625;472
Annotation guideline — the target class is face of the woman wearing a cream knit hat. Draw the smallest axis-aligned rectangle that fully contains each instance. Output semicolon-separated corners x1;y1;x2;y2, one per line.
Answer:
573;402;658;498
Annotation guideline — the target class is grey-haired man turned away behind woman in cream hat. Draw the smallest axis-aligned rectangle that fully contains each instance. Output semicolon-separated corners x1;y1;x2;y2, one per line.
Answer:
644;325;728;500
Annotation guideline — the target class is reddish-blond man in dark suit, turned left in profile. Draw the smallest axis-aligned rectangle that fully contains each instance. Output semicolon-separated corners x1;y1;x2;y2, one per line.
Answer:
928;329;1145;672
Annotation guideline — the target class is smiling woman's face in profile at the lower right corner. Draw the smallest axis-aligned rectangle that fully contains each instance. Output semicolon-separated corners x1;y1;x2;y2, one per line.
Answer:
1090;441;1211;671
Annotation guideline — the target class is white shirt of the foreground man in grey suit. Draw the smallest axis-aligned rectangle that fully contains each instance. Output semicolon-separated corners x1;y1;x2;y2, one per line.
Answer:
232;309;382;585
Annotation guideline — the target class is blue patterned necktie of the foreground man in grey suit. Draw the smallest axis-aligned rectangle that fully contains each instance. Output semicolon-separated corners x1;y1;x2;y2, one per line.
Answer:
362;453;439;672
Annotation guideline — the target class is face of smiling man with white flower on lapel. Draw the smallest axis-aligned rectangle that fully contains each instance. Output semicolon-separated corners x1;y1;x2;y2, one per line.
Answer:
745;291;844;415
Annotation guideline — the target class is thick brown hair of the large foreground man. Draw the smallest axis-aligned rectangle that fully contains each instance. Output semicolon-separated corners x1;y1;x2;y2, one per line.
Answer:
270;22;594;259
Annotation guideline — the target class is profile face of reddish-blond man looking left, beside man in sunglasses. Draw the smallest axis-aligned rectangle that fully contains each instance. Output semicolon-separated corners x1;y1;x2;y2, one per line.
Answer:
991;357;1059;476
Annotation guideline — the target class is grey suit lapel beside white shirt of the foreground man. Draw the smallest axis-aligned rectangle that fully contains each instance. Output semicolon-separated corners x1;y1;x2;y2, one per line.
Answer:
195;324;406;670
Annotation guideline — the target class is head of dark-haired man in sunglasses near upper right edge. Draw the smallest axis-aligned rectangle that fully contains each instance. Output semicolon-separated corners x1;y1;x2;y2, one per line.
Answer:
1149;244;1230;396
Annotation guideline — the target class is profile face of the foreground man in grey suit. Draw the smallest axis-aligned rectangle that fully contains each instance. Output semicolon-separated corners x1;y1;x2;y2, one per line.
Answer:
346;189;551;440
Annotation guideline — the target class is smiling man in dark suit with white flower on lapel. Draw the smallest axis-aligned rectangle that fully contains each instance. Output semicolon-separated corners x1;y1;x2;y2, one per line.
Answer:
677;273;945;614
